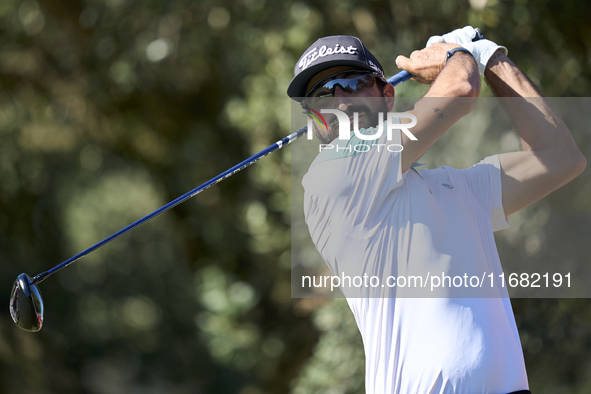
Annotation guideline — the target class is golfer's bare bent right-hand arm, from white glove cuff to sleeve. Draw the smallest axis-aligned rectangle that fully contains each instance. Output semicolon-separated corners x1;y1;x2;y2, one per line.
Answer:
484;51;587;216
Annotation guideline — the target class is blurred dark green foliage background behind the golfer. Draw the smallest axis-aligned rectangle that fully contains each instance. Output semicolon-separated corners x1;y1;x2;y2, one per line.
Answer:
0;0;591;394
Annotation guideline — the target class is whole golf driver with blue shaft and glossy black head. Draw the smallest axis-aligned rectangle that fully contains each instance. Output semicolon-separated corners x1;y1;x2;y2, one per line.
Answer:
10;29;483;332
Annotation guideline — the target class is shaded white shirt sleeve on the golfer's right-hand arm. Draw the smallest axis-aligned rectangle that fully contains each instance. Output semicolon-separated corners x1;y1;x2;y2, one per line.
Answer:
462;155;509;231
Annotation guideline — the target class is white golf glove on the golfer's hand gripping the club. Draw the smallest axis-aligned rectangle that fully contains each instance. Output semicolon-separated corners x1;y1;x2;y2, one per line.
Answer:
426;26;509;75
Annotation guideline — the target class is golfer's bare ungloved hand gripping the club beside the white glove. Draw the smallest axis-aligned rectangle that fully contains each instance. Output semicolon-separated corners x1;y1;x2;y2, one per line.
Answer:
396;43;469;85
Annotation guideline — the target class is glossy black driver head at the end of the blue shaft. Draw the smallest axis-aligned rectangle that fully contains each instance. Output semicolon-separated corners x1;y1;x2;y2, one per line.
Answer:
10;274;43;332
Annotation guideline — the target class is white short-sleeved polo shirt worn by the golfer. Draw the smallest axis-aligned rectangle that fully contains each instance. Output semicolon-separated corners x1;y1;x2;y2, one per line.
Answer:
302;131;528;394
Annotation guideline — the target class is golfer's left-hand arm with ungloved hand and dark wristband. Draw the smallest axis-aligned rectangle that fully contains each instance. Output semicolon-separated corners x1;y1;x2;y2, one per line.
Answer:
396;44;480;173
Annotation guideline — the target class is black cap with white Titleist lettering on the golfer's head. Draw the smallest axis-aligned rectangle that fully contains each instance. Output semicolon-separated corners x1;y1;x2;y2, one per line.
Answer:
287;36;384;101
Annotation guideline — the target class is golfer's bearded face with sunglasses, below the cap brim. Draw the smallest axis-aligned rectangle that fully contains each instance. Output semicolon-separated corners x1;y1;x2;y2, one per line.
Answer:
303;66;394;144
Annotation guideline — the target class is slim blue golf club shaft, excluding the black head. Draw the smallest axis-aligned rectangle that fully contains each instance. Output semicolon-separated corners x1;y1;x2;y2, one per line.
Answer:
31;67;412;285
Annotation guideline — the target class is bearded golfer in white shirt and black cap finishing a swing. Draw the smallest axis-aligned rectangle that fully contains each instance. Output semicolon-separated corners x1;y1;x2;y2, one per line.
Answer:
288;26;586;394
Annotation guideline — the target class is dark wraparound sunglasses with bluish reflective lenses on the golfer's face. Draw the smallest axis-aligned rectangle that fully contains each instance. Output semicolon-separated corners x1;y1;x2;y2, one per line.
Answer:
301;70;386;108
